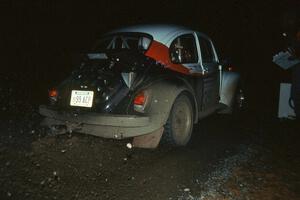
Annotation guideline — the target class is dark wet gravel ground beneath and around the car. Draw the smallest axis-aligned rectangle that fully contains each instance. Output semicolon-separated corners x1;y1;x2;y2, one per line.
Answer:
0;103;300;200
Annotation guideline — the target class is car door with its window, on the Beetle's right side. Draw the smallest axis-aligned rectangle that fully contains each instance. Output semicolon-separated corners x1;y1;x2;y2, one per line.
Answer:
197;33;220;110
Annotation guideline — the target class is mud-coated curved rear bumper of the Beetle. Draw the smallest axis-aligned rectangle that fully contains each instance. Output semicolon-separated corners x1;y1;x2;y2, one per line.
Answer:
39;105;161;139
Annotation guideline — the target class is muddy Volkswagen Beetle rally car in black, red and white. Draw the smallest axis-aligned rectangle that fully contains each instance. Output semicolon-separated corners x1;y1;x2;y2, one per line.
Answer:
39;25;244;148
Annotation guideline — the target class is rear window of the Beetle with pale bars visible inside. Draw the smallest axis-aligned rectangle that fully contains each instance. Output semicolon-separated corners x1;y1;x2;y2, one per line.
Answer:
93;33;151;52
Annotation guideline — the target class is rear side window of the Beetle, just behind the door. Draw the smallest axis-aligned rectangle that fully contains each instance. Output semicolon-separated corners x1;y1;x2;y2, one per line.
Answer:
170;34;198;63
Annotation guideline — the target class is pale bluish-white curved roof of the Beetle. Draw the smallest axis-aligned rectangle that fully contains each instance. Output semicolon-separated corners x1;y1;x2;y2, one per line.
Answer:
110;24;193;42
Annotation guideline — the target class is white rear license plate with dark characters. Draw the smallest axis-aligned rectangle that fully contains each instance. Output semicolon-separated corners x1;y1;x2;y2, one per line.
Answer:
70;90;94;108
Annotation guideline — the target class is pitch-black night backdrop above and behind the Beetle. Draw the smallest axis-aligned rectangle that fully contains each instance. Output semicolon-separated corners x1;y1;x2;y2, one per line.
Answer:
0;0;299;116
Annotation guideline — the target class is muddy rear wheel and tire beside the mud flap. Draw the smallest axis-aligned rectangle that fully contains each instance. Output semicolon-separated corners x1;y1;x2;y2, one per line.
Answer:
162;94;194;146
